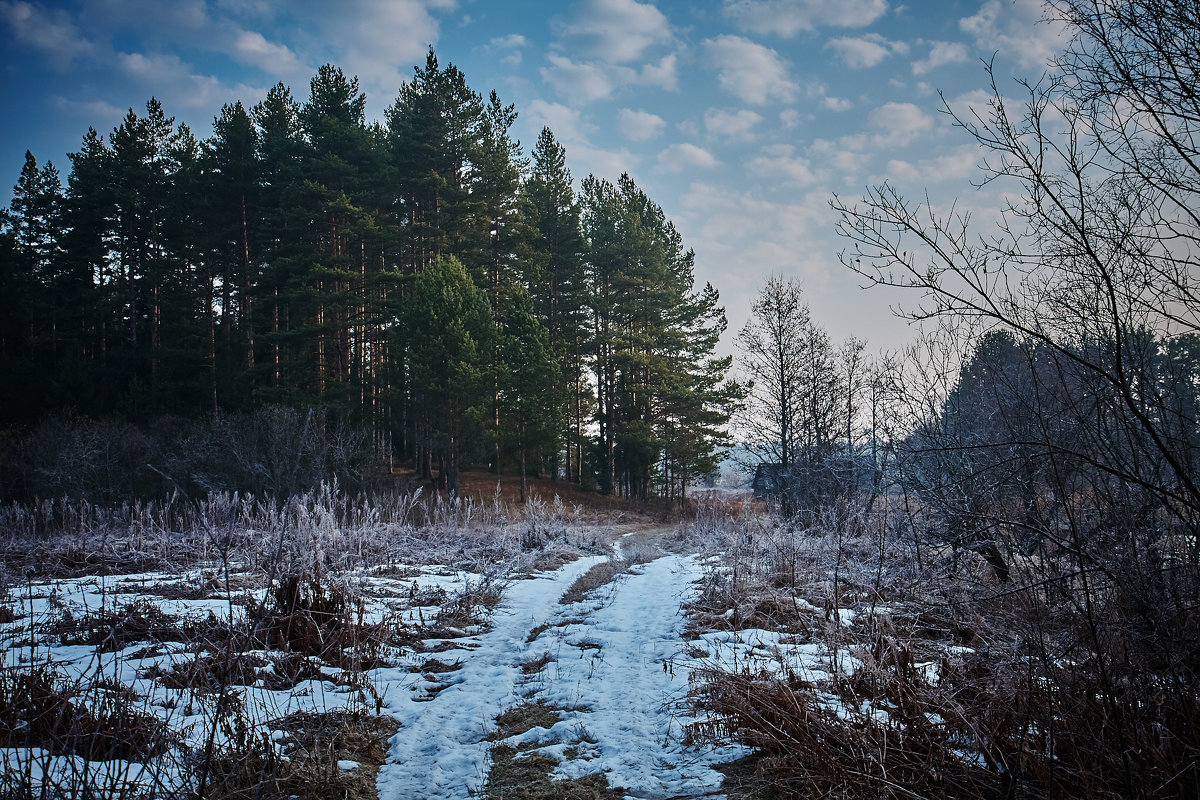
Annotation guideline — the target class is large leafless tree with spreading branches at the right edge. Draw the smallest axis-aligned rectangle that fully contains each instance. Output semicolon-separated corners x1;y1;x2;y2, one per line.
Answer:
833;0;1200;796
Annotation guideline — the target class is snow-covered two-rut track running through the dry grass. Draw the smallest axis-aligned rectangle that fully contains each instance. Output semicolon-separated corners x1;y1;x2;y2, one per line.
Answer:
377;557;742;800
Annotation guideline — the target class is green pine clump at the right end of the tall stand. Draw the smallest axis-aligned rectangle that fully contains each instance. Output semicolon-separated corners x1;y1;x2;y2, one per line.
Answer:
583;175;738;499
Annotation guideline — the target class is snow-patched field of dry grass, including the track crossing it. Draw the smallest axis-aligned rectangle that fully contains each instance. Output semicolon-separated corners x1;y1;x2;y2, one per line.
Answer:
0;493;1176;800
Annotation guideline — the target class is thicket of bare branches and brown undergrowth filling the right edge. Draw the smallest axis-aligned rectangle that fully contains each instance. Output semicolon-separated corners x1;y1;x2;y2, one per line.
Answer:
700;0;1200;798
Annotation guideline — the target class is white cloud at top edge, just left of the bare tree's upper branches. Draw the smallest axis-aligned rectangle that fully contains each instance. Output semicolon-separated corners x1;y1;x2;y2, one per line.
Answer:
959;0;1069;68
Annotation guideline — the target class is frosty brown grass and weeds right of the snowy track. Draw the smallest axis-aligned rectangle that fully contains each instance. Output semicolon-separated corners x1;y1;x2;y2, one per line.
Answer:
676;499;1200;799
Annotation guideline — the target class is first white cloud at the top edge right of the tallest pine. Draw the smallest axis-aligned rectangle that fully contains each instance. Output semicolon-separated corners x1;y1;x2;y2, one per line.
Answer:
559;0;671;64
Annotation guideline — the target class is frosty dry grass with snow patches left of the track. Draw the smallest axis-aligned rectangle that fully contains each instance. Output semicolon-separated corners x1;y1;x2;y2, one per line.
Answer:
0;489;609;798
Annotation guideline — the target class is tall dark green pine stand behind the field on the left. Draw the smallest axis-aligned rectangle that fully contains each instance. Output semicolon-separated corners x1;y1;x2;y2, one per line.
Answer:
0;49;738;498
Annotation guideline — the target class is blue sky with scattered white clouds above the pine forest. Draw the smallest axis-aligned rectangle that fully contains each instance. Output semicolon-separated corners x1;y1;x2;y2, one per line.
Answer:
0;0;1066;351
